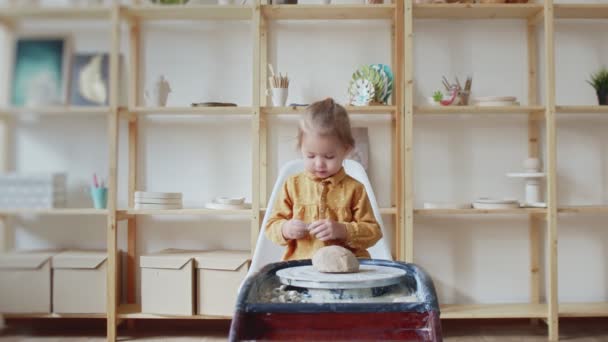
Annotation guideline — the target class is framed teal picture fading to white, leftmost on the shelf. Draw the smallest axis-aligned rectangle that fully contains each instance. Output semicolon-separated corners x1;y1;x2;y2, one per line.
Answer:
10;36;71;107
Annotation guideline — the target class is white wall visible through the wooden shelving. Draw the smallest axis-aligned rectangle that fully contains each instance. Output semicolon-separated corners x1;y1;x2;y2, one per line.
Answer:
0;0;608;303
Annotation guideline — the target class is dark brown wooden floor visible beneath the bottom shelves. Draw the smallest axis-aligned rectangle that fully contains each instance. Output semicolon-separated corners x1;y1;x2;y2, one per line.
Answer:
0;319;608;342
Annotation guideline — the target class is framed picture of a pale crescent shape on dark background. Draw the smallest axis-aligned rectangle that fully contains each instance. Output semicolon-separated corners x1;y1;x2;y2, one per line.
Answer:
70;53;110;106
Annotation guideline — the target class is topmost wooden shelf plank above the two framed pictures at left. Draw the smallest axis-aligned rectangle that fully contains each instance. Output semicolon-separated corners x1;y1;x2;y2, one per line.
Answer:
0;6;111;21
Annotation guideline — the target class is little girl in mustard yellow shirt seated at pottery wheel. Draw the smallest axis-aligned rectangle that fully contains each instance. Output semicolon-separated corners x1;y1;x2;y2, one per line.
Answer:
264;98;382;260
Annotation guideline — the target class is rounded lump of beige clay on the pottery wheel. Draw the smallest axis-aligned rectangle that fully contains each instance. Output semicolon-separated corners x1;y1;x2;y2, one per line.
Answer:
312;246;359;273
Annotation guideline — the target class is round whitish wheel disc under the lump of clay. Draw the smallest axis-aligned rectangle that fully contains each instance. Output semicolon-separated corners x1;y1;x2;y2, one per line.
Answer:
276;265;405;289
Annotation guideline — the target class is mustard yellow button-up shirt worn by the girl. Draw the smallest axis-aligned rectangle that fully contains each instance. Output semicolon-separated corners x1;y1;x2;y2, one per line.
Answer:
265;168;382;260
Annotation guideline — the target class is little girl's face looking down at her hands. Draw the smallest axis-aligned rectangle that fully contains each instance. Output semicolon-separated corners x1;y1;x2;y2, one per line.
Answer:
301;133;350;178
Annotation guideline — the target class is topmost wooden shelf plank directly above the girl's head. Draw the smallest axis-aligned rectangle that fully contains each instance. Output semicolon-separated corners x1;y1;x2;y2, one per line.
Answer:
262;4;395;20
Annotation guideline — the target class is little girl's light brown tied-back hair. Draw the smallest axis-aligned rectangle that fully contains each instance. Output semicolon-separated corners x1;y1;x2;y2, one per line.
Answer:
298;97;355;148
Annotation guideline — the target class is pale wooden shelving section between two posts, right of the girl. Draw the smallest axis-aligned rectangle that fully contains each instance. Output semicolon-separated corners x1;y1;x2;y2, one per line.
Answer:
404;0;559;340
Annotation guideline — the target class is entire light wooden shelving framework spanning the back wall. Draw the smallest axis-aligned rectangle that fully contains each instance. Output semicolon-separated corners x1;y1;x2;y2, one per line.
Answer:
0;0;608;341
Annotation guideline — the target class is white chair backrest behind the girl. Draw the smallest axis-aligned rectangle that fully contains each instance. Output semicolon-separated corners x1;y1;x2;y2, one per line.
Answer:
248;159;393;275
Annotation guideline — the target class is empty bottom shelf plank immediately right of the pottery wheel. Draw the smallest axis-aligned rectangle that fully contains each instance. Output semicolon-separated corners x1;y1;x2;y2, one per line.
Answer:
440;304;548;319
